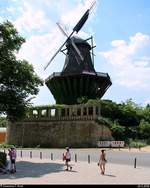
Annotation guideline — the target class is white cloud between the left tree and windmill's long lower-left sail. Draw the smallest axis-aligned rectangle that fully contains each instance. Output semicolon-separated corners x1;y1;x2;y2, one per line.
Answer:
17;28;63;78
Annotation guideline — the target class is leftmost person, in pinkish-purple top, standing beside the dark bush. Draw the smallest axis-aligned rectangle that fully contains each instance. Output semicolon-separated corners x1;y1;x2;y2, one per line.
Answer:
8;146;17;173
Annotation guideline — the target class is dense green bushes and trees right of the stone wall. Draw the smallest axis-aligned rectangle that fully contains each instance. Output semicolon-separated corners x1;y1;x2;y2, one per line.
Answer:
87;99;150;140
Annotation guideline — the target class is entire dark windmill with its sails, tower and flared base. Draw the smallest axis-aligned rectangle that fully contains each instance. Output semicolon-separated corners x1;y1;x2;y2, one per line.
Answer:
44;1;112;105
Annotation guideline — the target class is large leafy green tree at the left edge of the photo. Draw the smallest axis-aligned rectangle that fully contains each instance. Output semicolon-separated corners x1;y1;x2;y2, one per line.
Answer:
0;21;43;121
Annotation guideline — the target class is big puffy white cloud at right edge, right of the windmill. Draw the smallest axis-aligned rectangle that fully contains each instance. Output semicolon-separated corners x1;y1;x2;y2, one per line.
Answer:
99;33;150;89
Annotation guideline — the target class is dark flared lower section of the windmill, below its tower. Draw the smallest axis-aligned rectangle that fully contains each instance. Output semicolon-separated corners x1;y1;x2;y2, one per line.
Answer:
45;73;112;105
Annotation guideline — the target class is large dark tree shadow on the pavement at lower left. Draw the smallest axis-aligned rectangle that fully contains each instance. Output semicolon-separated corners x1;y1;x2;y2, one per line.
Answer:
0;161;64;179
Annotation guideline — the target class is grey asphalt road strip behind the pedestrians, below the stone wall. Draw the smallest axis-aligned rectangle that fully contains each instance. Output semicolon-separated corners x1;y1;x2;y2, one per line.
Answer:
6;149;150;167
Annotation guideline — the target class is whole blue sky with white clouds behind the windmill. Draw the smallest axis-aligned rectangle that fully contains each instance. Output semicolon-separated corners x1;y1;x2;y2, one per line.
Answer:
0;0;150;105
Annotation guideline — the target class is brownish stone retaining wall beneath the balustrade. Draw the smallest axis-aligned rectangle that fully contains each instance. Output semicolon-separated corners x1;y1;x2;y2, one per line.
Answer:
6;120;112;147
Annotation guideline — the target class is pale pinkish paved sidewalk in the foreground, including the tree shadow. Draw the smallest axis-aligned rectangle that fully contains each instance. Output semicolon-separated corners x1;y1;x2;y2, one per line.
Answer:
0;158;150;185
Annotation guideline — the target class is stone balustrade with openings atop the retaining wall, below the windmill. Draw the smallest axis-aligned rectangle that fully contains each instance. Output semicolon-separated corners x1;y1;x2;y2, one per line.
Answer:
26;104;101;121
